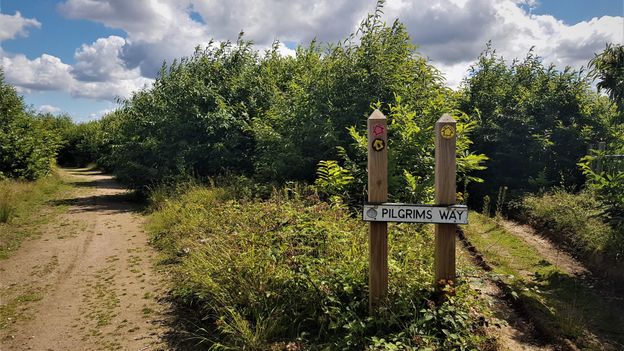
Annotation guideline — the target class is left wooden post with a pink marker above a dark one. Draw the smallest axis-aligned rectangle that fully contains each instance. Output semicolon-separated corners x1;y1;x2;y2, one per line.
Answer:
368;110;388;315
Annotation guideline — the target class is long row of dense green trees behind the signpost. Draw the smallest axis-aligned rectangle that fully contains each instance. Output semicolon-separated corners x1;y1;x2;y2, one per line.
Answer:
0;9;624;214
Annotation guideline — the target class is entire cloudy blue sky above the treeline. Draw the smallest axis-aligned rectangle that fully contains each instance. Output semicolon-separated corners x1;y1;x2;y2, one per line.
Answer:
0;0;624;121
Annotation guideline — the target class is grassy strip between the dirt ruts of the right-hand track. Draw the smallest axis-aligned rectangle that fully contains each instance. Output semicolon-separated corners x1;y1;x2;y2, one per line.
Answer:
465;213;624;350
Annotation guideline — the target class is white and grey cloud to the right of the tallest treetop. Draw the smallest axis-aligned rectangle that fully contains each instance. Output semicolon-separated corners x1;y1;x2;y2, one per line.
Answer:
385;0;624;87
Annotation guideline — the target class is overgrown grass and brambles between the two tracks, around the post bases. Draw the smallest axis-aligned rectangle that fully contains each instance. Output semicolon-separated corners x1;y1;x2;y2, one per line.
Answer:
149;187;496;350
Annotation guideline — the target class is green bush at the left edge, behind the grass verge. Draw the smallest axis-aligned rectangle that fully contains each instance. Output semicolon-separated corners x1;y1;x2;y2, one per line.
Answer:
0;70;61;180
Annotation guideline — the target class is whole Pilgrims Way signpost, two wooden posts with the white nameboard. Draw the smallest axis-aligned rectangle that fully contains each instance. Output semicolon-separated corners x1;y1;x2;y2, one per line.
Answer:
362;110;468;314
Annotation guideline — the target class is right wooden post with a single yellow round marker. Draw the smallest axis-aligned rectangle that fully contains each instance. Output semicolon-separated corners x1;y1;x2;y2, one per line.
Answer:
435;114;457;288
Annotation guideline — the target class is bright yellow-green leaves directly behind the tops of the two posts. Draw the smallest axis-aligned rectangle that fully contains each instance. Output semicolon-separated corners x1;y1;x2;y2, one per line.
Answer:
346;97;487;203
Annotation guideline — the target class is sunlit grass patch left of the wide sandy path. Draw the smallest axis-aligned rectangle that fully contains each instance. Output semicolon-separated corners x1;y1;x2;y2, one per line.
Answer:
0;173;72;259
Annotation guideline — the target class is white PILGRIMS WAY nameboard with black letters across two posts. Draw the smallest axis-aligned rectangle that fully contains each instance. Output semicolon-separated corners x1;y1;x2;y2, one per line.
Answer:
362;203;468;224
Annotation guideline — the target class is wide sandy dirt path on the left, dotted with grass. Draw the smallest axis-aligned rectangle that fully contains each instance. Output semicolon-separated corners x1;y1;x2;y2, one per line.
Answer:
0;170;168;351
